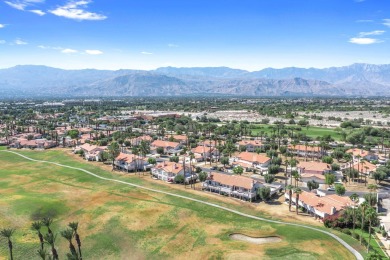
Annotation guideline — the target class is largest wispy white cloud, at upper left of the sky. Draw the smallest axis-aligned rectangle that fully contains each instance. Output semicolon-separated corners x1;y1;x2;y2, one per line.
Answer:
49;0;107;21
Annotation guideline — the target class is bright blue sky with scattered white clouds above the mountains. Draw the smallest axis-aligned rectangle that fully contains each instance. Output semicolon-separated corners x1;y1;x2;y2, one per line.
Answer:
0;0;390;71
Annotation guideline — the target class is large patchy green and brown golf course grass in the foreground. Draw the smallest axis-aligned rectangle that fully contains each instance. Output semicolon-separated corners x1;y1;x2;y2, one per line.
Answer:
0;150;362;259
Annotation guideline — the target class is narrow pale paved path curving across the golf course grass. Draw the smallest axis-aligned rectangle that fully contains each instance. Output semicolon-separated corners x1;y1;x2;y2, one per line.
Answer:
1;151;364;260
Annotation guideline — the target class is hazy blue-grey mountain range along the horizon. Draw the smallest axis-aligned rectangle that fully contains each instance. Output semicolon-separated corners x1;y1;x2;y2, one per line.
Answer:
0;63;390;98
